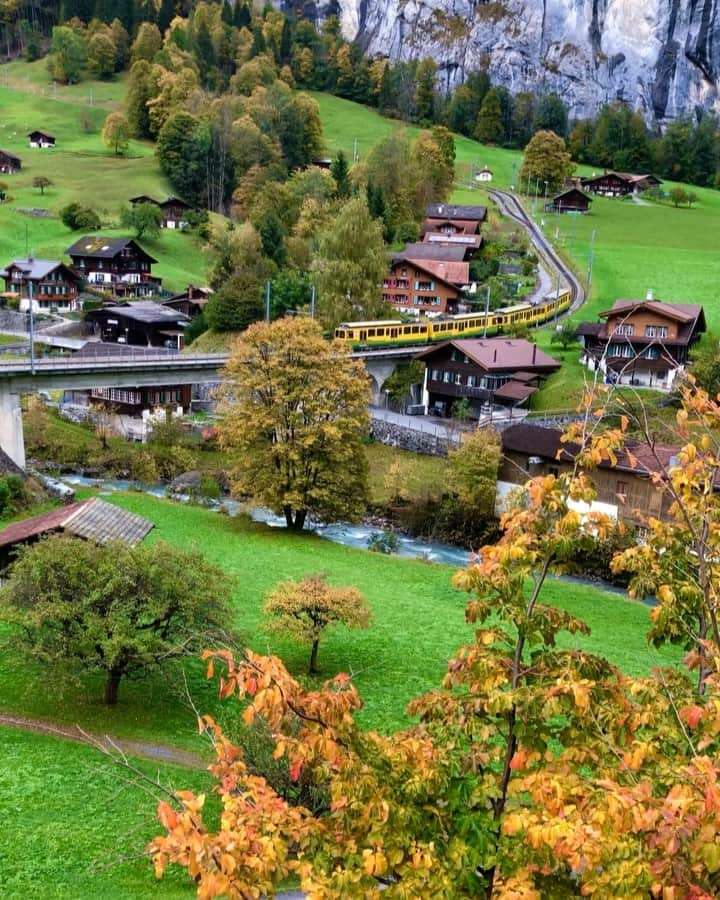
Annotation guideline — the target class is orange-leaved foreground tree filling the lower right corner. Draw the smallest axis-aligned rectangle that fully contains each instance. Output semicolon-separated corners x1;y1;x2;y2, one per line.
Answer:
149;389;720;900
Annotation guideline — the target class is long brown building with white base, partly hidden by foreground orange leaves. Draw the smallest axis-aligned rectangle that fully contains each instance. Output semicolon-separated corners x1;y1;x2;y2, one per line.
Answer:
497;423;679;525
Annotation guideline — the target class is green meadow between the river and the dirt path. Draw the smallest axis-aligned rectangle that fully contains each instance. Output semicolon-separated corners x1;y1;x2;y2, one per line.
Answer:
0;493;679;750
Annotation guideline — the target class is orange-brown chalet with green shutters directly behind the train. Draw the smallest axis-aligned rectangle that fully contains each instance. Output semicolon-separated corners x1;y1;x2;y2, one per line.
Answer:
382;255;467;316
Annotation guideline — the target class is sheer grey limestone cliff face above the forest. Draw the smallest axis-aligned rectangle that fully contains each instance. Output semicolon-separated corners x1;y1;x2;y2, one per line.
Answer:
283;0;720;121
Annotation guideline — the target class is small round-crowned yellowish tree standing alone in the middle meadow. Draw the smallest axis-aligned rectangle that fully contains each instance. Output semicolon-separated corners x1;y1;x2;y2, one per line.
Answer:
263;575;371;675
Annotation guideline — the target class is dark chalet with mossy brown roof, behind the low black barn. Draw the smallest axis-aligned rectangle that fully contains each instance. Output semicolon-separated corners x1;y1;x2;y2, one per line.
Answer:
66;235;162;297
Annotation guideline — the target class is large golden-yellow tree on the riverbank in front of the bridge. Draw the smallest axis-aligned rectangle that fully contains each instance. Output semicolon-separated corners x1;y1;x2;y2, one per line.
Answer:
220;318;370;529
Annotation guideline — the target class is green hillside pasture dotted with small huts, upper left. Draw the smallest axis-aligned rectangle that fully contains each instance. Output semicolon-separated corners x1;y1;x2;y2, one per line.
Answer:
0;83;205;291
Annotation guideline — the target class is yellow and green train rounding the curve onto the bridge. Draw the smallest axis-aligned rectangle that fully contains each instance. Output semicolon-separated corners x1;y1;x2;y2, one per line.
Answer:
335;288;571;348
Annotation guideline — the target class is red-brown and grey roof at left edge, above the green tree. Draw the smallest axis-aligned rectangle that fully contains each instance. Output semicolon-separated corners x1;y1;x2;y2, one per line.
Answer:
0;497;153;547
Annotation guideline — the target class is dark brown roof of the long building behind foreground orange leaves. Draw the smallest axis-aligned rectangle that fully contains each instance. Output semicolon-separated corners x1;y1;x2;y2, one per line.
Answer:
501;423;680;476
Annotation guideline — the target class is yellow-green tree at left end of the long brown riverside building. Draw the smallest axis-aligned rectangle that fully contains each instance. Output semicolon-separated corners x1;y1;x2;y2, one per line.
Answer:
446;428;502;516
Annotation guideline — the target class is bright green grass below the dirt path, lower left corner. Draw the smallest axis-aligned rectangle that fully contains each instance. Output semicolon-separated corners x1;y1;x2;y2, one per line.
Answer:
0;728;209;900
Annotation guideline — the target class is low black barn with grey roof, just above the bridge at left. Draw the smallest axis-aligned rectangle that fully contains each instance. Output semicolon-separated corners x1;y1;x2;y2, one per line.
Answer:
85;300;189;350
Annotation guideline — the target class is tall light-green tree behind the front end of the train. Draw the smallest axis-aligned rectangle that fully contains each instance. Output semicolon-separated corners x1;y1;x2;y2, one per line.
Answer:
313;197;387;329
